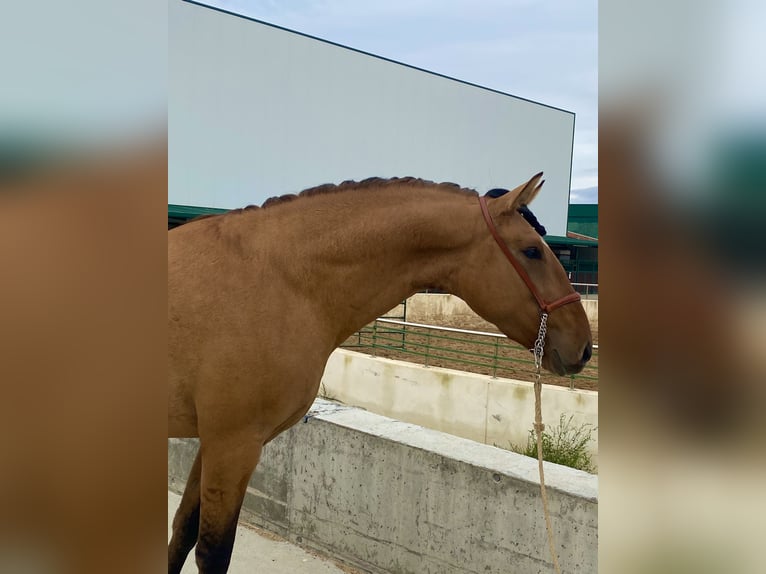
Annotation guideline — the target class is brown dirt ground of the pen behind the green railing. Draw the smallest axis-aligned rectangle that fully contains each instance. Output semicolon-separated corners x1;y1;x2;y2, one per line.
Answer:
343;317;598;391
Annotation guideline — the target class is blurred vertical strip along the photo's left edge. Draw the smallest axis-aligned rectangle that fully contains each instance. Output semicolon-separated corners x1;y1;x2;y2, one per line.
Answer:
0;0;167;574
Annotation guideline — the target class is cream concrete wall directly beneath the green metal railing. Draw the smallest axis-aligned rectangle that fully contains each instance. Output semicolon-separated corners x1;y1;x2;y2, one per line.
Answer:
320;349;598;460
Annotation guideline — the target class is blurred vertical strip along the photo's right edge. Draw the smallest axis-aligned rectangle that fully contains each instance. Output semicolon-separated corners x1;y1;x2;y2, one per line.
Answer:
599;0;766;573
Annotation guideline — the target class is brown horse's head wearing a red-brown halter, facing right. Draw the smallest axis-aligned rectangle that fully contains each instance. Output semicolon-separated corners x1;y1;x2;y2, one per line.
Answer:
460;173;592;375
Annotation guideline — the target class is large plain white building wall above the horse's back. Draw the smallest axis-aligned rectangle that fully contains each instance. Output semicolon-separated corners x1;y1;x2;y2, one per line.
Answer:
168;0;574;235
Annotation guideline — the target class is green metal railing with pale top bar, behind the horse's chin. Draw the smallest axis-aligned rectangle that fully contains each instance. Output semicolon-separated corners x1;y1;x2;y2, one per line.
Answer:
341;318;598;389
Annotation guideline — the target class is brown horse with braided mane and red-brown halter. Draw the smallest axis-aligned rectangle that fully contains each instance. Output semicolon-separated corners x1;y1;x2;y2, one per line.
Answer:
168;174;591;574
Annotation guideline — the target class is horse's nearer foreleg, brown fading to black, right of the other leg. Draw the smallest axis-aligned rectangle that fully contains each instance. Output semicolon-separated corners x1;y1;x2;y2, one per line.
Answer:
196;436;263;574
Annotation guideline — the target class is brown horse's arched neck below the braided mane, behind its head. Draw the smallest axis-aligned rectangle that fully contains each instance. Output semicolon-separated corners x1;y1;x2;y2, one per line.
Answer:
268;189;480;343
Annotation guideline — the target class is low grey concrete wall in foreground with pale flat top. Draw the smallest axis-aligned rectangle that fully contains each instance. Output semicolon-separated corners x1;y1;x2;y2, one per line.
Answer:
168;400;598;574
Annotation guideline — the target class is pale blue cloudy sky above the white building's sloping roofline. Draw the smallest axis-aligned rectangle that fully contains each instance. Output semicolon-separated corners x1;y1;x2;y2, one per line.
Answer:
204;0;598;203
